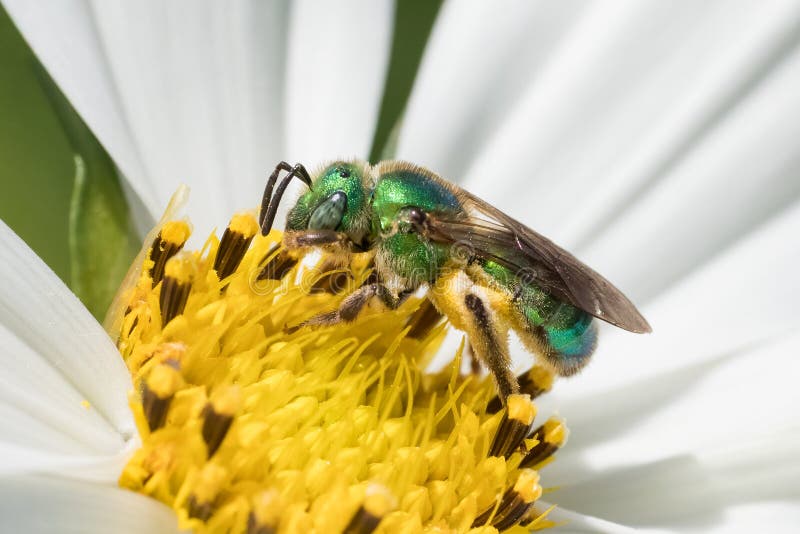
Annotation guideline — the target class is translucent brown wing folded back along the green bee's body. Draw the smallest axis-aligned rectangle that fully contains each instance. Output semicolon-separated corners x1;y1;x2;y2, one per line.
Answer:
427;190;651;333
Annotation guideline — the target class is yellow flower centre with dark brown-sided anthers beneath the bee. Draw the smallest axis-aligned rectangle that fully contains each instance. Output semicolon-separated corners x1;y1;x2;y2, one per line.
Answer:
117;213;567;533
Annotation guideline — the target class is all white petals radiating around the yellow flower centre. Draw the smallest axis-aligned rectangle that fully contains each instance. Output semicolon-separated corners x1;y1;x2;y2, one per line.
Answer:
0;0;800;532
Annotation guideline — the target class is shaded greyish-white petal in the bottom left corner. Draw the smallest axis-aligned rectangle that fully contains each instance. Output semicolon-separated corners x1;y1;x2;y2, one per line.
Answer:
0;477;178;534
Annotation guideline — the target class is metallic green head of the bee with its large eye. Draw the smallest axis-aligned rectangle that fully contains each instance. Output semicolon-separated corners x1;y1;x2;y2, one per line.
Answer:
286;161;372;244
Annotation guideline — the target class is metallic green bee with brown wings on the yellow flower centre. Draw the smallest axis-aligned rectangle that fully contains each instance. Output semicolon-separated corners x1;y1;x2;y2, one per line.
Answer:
259;160;650;401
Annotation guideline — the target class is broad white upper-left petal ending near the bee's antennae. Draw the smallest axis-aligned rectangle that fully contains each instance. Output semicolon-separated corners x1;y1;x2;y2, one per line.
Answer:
6;0;288;234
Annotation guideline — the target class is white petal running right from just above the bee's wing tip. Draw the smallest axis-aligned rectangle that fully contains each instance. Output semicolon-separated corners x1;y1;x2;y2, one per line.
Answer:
578;36;800;302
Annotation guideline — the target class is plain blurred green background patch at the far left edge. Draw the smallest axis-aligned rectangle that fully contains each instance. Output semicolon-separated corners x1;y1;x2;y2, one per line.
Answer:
0;5;74;283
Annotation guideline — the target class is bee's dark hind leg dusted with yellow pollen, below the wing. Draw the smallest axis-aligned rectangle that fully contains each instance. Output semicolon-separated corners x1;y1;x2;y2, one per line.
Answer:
464;293;519;405
